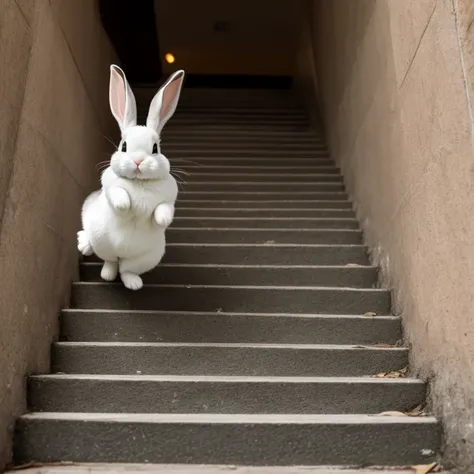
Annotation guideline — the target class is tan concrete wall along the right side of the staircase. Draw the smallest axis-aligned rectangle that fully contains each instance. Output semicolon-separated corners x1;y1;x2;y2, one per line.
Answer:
299;0;474;472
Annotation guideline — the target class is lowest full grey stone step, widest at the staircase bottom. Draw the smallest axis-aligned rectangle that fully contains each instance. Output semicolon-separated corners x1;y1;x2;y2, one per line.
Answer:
14;413;440;466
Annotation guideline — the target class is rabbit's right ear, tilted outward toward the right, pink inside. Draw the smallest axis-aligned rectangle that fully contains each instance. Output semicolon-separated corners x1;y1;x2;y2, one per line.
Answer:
146;71;184;133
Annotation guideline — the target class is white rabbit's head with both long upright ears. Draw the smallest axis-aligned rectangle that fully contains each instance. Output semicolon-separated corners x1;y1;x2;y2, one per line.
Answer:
109;65;184;179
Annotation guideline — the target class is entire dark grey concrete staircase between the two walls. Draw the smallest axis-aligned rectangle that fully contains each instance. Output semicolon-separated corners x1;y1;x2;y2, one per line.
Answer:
15;89;440;466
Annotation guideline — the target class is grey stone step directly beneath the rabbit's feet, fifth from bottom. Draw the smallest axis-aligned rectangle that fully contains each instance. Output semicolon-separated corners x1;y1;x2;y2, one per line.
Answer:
71;282;390;315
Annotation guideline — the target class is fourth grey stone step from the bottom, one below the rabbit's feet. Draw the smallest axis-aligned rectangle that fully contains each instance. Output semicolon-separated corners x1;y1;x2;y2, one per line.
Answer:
61;309;402;345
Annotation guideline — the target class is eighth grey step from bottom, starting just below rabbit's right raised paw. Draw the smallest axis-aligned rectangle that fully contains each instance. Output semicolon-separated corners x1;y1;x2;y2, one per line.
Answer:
166;229;362;245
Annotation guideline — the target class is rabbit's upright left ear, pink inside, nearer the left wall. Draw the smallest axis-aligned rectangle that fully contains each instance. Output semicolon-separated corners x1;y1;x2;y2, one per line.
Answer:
109;64;137;132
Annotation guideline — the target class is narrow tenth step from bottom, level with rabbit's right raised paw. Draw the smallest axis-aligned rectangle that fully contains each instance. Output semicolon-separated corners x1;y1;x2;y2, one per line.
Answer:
175;206;355;219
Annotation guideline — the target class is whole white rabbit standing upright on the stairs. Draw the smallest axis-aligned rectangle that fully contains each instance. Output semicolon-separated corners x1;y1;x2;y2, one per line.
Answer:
77;65;184;290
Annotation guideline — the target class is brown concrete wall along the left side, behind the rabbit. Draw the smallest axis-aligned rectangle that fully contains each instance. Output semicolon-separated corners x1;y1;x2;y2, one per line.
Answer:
0;0;115;471
